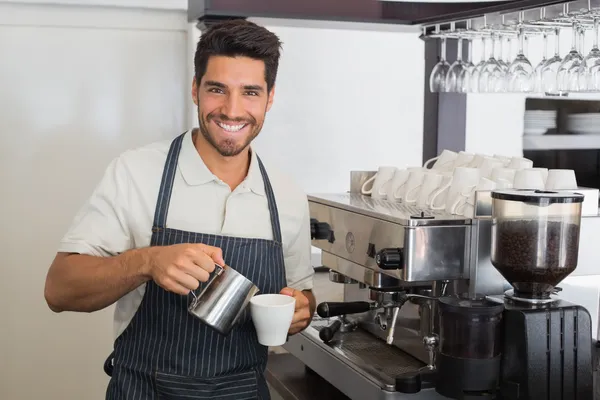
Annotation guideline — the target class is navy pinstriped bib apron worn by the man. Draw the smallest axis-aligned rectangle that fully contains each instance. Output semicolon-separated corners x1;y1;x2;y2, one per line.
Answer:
106;134;286;400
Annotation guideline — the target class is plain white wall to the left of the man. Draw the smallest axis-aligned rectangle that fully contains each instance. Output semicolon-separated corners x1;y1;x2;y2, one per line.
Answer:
0;3;188;400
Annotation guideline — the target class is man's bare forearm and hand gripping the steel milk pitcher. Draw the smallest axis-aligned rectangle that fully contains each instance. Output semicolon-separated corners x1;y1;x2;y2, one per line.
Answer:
44;243;224;312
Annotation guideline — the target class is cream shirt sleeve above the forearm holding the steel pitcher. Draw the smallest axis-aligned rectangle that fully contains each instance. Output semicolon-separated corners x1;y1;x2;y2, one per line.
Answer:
58;156;133;257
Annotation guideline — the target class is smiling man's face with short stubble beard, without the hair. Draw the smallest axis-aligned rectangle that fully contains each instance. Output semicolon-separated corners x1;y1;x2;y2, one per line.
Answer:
192;56;274;157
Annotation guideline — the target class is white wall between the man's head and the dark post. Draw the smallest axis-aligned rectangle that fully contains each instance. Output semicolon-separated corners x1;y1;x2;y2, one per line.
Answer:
190;19;425;193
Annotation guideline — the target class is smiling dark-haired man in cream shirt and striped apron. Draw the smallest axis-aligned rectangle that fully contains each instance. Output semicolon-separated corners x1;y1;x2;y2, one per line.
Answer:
45;20;315;400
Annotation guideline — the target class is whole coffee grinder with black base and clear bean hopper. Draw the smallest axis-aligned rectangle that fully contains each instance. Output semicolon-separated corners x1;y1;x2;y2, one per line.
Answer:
436;190;594;400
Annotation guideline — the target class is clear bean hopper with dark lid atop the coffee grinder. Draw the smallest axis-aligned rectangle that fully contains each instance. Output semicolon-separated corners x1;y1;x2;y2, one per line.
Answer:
491;190;584;299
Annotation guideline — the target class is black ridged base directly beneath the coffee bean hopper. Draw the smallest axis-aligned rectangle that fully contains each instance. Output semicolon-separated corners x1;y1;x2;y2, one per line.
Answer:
500;300;594;400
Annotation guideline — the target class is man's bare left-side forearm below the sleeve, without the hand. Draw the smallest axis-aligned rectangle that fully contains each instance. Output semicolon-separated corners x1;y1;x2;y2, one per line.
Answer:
44;249;150;312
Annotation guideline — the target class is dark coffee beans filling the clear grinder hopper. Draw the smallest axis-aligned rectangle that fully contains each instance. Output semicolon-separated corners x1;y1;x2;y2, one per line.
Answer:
492;220;579;297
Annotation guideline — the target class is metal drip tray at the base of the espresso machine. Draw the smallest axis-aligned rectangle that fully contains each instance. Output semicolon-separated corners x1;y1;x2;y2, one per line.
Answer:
305;317;425;391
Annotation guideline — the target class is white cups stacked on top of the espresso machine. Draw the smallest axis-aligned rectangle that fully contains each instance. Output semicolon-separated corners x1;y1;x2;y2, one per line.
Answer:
361;150;578;217
